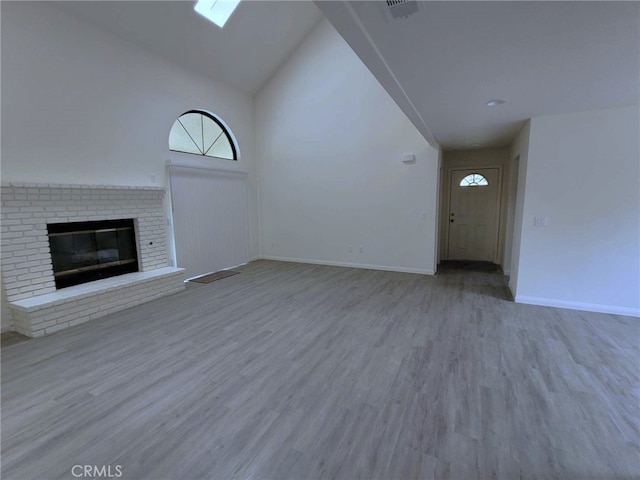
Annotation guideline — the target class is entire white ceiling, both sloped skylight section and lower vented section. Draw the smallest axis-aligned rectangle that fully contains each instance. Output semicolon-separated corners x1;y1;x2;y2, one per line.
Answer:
55;0;640;149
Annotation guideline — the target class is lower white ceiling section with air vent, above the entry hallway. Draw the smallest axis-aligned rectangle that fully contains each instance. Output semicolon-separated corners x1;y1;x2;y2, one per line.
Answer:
316;1;640;149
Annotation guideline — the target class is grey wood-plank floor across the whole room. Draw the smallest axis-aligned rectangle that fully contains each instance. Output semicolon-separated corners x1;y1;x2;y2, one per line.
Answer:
2;261;640;480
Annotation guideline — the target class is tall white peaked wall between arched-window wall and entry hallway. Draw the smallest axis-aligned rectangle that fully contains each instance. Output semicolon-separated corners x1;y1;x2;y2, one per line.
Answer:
256;20;439;273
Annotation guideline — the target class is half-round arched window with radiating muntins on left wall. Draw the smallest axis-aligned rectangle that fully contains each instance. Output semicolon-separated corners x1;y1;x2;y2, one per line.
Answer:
169;110;238;160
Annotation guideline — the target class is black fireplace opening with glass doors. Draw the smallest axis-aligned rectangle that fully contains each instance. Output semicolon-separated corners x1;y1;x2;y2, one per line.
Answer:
47;219;138;289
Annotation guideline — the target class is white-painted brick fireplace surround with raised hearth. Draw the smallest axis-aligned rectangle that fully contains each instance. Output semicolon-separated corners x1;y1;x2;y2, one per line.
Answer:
1;182;184;337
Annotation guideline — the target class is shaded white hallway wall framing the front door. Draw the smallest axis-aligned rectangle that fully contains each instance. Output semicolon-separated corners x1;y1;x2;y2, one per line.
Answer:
439;148;511;275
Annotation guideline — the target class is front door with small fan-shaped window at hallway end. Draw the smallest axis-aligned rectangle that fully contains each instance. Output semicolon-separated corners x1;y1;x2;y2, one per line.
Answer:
448;168;501;262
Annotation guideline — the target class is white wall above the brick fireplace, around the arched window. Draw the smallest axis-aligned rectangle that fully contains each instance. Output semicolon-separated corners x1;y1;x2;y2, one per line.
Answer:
1;2;258;262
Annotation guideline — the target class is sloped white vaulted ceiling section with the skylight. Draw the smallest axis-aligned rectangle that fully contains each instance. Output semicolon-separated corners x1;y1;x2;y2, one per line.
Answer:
51;0;322;95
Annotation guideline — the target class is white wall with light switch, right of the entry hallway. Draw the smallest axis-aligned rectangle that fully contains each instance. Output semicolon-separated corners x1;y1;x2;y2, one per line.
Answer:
513;106;640;315
